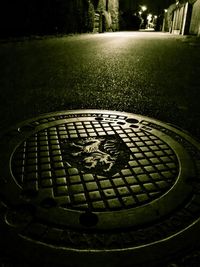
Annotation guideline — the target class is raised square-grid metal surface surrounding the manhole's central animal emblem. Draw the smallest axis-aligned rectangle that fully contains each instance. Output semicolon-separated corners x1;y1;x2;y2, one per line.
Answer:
12;120;179;211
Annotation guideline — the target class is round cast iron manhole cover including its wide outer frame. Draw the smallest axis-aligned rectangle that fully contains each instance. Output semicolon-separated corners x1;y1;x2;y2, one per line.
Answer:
0;110;200;266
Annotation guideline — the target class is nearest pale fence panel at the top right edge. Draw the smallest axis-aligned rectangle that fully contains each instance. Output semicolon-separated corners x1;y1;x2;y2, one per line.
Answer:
189;0;200;35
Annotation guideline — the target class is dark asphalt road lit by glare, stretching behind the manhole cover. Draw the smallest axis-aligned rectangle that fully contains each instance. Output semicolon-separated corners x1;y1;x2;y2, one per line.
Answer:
0;32;200;137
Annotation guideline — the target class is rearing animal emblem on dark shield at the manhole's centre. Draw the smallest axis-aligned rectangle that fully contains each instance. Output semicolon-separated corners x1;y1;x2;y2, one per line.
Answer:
61;135;130;175
